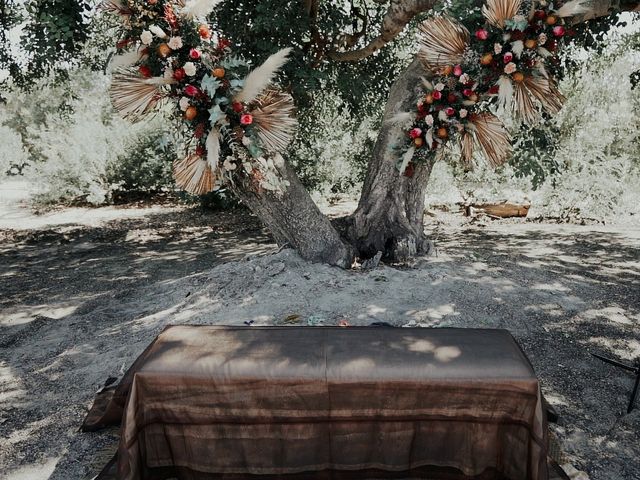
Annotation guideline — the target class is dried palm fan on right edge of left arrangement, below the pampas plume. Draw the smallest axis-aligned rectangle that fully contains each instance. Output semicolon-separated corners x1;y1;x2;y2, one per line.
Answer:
250;88;297;153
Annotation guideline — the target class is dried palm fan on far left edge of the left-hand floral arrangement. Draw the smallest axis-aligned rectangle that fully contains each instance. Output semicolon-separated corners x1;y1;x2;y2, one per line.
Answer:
109;71;174;122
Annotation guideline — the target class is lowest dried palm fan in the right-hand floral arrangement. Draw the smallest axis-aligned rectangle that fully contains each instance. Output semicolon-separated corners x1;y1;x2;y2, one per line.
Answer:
462;112;511;168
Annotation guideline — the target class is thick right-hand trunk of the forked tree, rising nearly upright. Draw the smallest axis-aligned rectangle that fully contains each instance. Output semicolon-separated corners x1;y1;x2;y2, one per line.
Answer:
342;59;434;262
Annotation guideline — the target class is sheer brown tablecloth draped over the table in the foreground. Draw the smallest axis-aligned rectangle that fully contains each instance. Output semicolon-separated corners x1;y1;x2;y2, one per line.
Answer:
85;326;547;480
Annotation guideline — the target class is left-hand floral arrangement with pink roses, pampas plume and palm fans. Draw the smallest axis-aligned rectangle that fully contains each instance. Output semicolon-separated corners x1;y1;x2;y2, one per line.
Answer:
103;0;296;194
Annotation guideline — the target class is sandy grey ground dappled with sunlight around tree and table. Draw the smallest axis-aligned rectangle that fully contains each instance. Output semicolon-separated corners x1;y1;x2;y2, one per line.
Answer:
0;182;640;480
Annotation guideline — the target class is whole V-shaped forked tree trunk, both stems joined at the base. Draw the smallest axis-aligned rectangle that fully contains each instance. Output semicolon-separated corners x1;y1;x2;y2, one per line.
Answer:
232;60;433;268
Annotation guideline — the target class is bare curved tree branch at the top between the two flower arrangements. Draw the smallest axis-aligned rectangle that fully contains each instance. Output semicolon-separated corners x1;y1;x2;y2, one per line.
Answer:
327;0;437;62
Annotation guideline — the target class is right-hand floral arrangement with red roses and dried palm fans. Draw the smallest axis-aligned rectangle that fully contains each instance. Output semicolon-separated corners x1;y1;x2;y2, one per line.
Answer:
394;0;589;175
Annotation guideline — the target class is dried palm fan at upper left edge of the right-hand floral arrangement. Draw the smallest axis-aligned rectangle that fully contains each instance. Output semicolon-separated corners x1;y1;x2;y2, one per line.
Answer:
418;17;469;72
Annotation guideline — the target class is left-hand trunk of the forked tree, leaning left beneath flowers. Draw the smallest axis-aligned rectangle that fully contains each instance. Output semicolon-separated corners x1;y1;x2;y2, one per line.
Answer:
232;161;355;268
